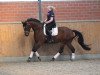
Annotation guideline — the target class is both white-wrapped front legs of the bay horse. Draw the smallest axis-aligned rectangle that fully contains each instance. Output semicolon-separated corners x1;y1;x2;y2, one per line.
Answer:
27;43;41;62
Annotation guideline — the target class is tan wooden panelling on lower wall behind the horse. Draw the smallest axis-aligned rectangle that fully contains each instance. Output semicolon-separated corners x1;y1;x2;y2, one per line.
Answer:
0;22;100;56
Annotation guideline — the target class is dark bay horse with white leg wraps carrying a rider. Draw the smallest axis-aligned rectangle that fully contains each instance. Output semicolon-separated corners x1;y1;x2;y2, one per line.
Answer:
22;18;91;62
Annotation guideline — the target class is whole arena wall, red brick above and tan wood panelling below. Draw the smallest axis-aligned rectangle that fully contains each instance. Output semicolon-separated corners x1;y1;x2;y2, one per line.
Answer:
0;0;100;57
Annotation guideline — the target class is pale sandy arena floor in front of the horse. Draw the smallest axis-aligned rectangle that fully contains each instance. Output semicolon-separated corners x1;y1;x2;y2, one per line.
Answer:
0;59;100;75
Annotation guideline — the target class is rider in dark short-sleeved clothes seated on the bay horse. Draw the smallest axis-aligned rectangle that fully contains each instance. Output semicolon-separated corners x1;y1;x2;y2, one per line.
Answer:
44;6;56;42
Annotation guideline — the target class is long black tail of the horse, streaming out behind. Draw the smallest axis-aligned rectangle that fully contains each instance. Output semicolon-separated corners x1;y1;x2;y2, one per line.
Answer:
73;30;91;50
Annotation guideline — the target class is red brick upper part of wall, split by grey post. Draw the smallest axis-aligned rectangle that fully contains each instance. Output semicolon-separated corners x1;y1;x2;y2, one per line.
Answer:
0;0;100;22
